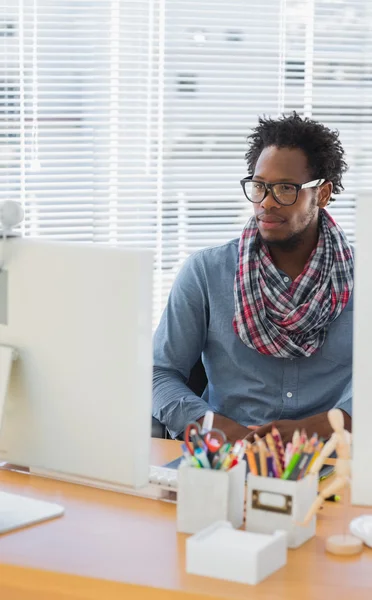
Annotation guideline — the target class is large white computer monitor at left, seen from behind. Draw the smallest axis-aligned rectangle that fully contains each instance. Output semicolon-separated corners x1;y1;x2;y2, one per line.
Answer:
0;238;153;487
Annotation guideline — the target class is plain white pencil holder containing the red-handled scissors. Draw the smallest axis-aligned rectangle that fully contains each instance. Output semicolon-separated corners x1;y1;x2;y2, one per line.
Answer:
177;461;246;533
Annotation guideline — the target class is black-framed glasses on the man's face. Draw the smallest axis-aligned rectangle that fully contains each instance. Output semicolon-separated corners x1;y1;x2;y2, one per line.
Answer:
240;177;325;206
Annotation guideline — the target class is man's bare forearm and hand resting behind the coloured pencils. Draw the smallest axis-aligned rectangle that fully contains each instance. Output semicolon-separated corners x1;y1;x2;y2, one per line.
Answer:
247;412;351;445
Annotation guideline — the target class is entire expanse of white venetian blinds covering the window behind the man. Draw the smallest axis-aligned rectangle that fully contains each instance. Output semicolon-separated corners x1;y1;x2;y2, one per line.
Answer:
0;0;372;323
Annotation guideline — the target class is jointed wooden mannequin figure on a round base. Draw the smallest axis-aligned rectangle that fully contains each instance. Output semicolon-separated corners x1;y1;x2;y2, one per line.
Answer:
303;408;363;554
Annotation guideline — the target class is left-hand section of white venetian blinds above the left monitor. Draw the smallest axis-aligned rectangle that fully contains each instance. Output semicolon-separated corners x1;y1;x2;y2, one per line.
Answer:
0;0;160;247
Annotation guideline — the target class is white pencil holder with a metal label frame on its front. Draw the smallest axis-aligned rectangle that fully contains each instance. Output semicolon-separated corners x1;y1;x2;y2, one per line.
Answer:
246;473;318;548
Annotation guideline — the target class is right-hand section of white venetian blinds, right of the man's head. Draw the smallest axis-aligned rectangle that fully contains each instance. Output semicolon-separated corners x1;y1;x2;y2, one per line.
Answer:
284;0;372;241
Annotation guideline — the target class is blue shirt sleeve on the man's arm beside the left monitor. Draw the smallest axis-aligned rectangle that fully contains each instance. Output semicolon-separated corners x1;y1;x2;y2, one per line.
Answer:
153;253;209;437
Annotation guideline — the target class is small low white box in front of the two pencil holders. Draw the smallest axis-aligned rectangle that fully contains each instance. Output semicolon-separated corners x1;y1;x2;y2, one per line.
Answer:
186;521;287;585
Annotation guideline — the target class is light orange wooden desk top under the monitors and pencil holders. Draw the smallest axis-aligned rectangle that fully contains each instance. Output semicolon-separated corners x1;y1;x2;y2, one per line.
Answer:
0;440;372;600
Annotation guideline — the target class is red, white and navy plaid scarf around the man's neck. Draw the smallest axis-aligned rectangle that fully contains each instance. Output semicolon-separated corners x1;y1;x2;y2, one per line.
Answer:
233;210;354;358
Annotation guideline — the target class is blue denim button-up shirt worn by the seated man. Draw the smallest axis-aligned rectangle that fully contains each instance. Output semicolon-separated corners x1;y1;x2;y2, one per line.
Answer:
153;239;353;437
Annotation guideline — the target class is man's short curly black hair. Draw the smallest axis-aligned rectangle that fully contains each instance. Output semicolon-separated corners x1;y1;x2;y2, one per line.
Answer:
245;111;348;194
